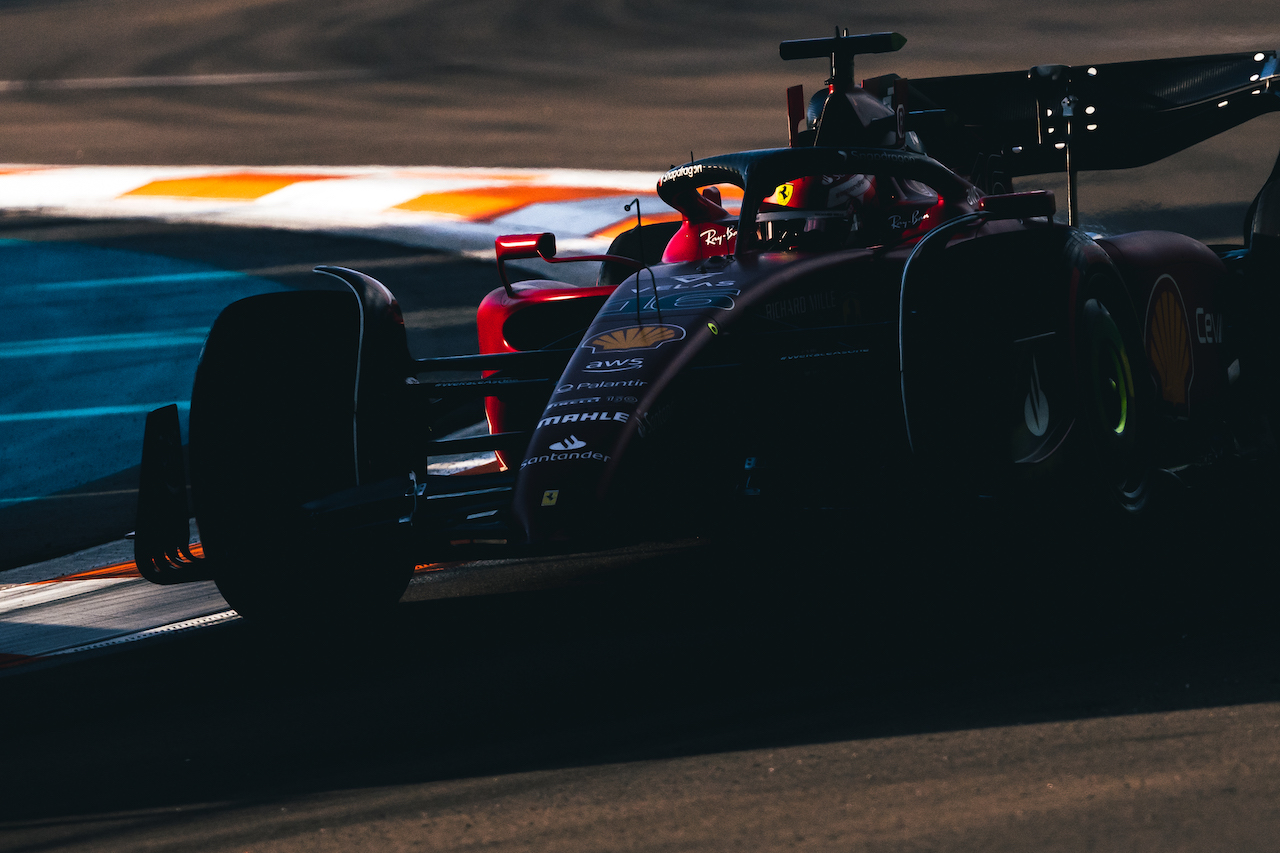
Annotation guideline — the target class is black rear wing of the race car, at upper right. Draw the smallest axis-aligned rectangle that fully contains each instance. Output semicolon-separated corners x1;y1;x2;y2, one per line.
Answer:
865;50;1280;180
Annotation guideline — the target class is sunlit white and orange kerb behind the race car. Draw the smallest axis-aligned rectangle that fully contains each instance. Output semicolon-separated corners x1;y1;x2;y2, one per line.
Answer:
0;164;672;283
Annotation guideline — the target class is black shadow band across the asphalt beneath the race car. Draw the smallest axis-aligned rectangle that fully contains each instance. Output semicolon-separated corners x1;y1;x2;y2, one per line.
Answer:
0;489;1280;820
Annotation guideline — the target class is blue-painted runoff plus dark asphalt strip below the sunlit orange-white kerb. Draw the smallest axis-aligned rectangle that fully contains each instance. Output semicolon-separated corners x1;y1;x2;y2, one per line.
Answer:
0;216;499;570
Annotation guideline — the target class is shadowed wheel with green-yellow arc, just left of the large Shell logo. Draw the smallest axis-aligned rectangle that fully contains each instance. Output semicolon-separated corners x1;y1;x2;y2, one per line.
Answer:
901;224;1155;511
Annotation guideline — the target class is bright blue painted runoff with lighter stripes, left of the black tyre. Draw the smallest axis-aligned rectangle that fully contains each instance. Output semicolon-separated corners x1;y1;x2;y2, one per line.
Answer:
0;240;283;507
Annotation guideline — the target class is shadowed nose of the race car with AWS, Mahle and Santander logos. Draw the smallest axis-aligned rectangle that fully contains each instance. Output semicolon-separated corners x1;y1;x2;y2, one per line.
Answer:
515;250;921;540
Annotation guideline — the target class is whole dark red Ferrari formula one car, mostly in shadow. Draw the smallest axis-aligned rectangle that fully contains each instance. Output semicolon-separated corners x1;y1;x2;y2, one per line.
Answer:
136;33;1280;619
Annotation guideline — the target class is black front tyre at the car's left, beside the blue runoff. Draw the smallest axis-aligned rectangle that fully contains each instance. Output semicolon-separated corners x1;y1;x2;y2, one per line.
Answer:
191;291;412;625
